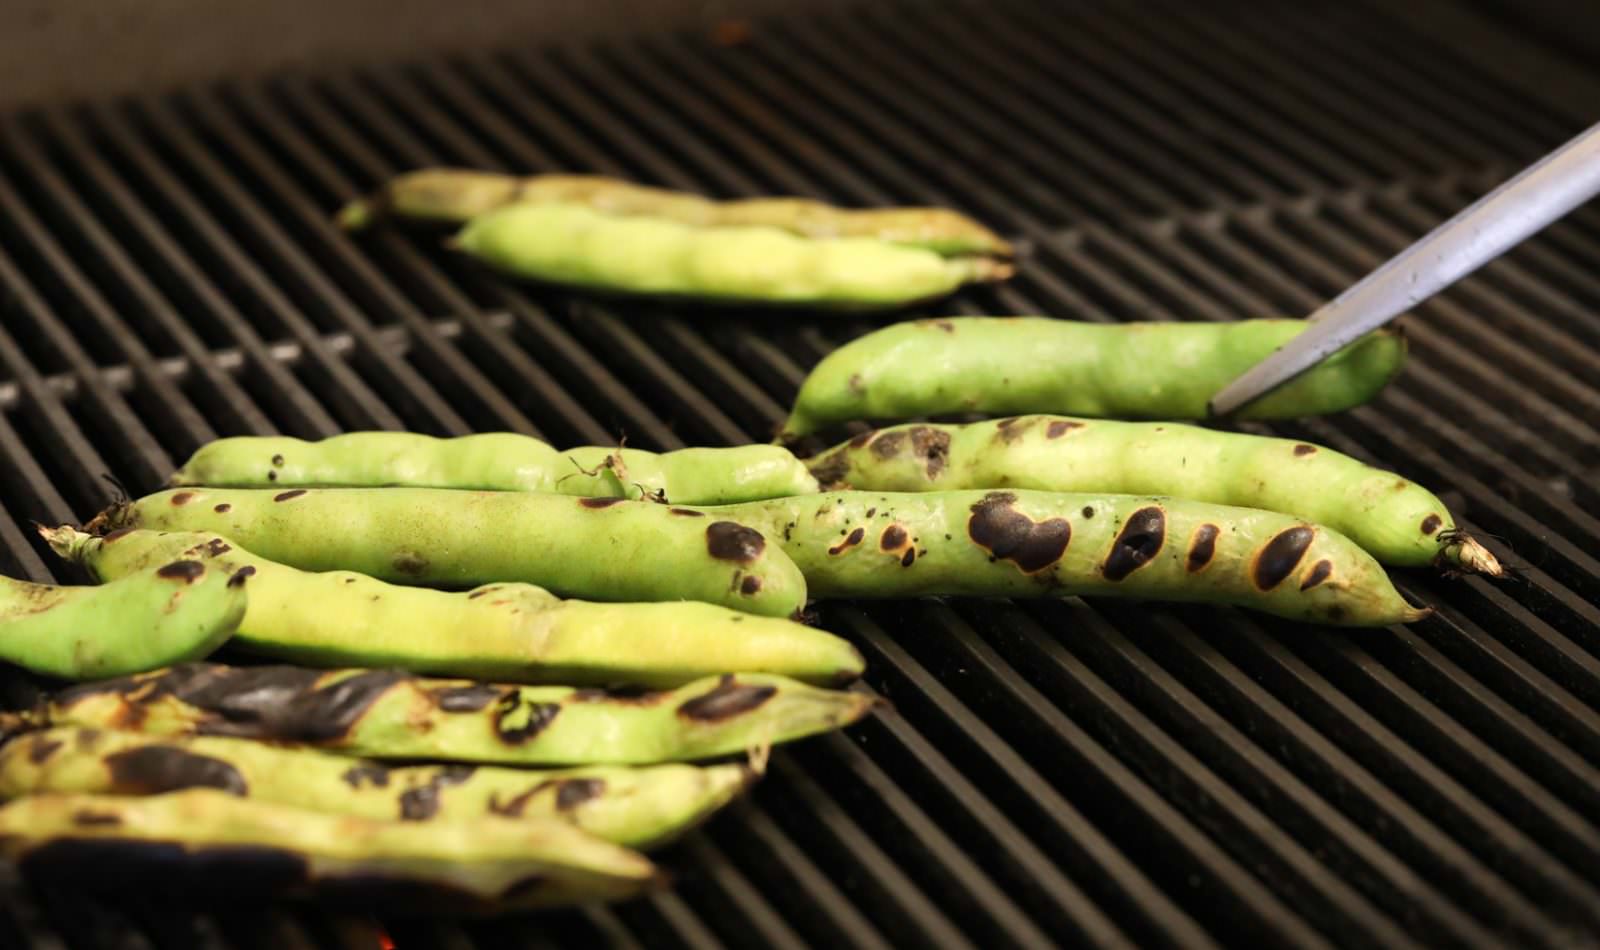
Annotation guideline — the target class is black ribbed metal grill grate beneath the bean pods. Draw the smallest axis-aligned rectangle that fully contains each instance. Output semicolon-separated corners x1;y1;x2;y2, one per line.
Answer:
0;0;1600;948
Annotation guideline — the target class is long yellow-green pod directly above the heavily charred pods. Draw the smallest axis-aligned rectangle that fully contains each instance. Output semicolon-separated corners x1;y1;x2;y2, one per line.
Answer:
40;528;864;688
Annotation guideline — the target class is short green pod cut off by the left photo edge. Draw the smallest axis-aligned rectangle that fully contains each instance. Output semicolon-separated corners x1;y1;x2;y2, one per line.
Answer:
0;557;246;680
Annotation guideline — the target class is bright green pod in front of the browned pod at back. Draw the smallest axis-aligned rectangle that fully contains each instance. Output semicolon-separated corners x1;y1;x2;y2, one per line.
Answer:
454;205;1013;310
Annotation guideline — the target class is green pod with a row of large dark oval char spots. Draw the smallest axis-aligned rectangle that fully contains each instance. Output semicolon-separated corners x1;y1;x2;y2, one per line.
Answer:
707;491;1430;627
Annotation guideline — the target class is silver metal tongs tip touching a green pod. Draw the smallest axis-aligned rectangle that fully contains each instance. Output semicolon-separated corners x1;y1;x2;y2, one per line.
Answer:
1210;125;1600;416
